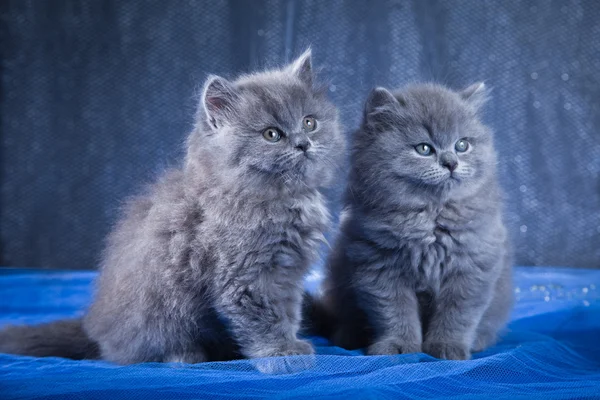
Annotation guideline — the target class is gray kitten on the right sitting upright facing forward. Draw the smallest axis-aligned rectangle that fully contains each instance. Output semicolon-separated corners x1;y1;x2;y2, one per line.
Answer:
307;83;512;360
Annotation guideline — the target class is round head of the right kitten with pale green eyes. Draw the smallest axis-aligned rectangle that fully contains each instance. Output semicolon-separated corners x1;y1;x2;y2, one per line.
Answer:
354;83;496;205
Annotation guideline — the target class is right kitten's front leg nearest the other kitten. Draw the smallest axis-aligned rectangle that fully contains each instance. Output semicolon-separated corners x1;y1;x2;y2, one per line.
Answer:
361;285;422;355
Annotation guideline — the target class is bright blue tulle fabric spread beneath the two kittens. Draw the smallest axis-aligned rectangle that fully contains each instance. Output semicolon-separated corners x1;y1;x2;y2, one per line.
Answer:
0;268;600;400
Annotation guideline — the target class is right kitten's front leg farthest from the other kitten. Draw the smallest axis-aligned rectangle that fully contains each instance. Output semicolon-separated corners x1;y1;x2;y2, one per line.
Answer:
423;271;491;360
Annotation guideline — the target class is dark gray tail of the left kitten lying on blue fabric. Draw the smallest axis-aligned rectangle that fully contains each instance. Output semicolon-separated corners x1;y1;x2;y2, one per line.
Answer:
0;318;99;360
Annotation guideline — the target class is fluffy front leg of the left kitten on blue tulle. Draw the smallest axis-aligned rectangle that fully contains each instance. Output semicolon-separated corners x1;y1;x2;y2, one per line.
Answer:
218;278;314;358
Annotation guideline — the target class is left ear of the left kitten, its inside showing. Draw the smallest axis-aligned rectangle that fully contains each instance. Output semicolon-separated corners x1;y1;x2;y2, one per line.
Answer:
202;75;238;129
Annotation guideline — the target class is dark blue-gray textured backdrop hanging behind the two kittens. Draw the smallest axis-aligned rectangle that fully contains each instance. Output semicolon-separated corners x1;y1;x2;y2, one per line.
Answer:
0;0;600;268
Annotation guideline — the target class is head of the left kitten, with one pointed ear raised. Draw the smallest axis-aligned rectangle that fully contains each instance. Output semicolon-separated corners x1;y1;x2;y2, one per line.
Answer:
188;49;344;190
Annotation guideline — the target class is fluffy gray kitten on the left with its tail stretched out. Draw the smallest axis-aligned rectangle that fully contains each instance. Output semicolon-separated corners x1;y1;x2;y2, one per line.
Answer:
0;50;344;364
